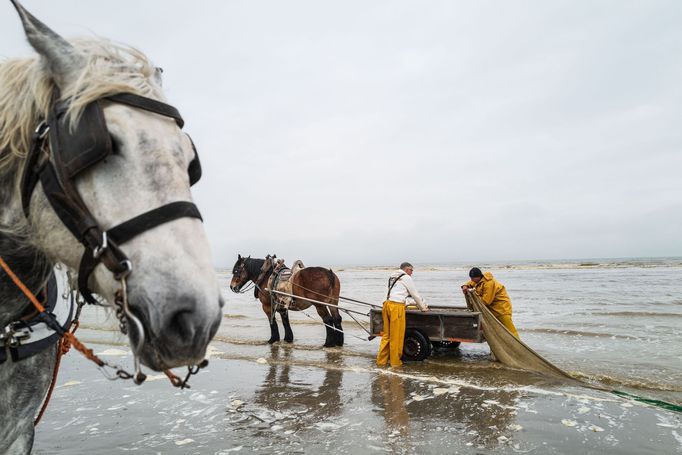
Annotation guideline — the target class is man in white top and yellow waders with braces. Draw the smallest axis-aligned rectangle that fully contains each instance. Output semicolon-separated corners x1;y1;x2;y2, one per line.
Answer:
377;262;429;367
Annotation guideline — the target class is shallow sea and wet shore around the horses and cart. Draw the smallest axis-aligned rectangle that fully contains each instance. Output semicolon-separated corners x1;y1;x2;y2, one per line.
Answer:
35;259;682;454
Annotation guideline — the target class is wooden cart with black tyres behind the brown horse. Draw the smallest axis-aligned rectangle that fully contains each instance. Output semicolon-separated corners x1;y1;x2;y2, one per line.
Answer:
369;306;484;360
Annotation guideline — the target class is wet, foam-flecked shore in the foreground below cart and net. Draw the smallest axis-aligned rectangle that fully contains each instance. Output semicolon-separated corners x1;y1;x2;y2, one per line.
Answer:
35;336;682;454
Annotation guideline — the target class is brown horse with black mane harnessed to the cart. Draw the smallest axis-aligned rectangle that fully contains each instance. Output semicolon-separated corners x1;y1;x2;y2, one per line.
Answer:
230;255;343;347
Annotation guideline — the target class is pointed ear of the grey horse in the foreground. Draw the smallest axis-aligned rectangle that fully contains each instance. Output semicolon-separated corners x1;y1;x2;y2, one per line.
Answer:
11;0;85;88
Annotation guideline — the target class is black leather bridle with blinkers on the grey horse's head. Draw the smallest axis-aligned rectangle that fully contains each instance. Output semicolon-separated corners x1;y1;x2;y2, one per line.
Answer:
21;90;202;303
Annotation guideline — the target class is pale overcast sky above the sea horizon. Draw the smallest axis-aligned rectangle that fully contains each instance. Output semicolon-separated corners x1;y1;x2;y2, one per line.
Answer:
0;0;682;266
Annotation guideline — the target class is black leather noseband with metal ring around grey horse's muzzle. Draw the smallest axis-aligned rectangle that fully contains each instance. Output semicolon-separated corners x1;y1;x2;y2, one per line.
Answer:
78;201;203;304
